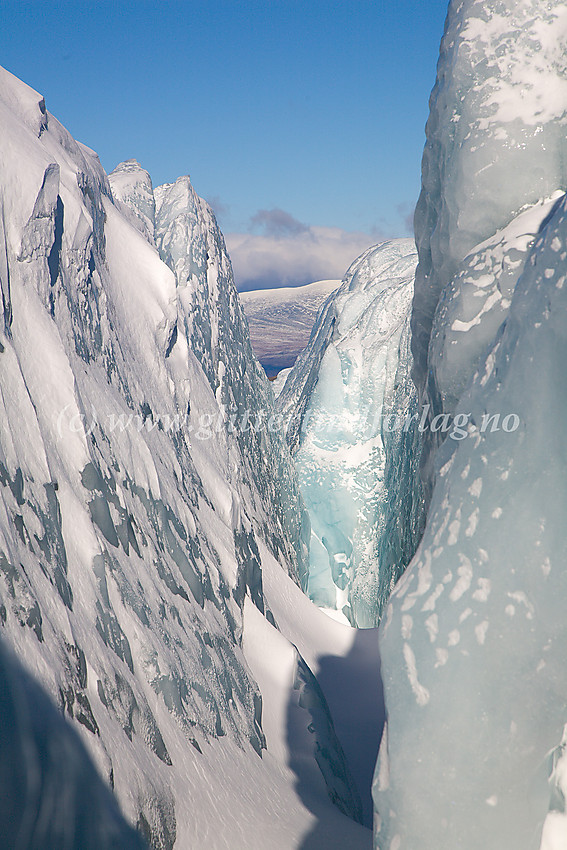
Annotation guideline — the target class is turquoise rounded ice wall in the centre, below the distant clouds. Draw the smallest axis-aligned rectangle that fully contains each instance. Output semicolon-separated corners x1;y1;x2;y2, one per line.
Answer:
278;239;421;627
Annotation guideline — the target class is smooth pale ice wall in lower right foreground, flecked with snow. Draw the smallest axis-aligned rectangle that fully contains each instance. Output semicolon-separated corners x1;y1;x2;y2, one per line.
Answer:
374;186;567;850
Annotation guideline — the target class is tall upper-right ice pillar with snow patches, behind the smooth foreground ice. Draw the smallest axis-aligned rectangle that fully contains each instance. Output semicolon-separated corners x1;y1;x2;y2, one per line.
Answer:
412;0;567;492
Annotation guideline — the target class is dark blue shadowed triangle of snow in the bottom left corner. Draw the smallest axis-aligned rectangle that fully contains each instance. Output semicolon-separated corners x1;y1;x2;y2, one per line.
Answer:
0;644;145;850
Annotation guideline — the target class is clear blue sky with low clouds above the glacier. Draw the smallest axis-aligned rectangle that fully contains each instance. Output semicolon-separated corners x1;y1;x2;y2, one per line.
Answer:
0;0;447;285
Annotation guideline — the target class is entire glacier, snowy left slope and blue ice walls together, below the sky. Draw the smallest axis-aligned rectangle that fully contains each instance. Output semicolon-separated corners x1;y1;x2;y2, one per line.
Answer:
12;0;567;850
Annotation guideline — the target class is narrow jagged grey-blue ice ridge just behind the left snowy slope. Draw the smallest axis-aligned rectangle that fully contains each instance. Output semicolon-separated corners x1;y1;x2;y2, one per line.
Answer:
155;177;309;586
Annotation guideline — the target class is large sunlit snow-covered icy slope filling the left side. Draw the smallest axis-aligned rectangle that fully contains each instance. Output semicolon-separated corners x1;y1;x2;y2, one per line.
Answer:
0;63;377;850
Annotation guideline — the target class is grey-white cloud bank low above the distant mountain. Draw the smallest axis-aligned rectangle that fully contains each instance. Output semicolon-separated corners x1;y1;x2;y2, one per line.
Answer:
226;209;383;291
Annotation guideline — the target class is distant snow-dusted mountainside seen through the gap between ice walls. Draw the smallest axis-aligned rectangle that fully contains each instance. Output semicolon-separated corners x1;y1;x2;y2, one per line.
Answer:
240;280;340;376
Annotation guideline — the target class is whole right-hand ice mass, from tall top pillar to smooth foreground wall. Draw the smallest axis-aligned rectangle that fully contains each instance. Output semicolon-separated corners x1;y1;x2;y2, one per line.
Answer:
373;0;567;850
